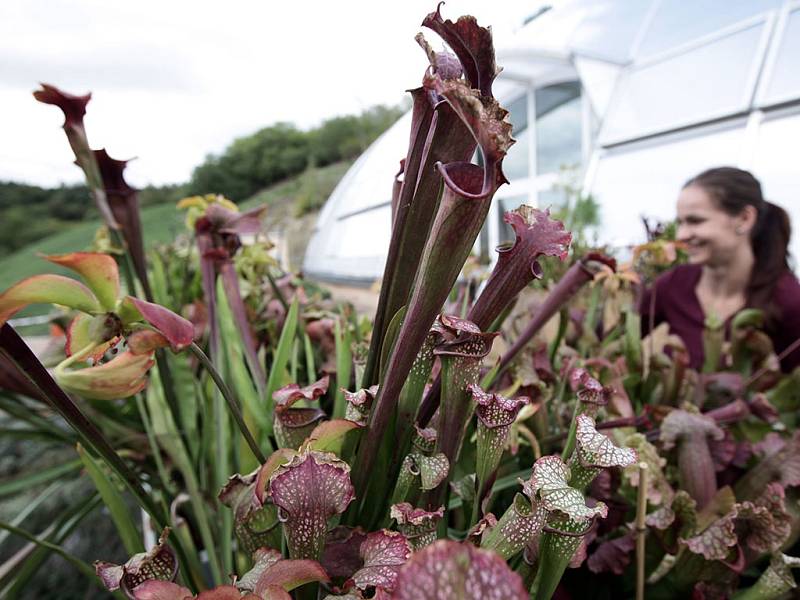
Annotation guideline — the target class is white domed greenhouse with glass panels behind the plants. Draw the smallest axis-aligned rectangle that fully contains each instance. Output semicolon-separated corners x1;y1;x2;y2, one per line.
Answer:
304;0;800;283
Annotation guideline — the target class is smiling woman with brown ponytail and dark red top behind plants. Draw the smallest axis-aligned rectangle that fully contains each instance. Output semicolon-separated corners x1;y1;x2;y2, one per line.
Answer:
639;167;800;371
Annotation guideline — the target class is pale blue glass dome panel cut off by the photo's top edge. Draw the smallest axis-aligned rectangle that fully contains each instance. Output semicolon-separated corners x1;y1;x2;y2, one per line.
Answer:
636;0;781;59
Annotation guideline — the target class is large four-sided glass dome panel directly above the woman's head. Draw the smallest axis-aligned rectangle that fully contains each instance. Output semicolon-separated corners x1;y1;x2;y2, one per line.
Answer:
600;24;764;145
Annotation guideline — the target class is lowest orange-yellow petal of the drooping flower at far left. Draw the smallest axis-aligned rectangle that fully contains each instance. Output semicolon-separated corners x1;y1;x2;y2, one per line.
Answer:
55;352;155;400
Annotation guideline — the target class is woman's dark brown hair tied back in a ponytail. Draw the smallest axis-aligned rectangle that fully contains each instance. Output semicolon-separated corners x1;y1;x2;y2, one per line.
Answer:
683;167;792;320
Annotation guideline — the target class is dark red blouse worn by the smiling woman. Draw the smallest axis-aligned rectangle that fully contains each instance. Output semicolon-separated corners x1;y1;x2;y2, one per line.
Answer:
639;265;800;372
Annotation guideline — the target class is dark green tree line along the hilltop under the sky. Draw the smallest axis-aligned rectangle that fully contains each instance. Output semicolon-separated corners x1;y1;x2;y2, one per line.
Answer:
0;106;405;257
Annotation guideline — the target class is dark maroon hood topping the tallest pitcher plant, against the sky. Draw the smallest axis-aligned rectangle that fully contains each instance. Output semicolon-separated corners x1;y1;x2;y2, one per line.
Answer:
422;5;500;96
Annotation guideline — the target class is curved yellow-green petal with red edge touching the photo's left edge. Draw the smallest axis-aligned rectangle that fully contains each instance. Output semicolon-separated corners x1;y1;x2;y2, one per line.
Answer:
0;274;103;325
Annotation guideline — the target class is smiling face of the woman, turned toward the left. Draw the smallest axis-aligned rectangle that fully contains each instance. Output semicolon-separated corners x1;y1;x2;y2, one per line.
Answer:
677;185;752;266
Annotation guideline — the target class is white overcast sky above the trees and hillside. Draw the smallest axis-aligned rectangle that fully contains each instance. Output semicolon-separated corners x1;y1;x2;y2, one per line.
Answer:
0;0;537;186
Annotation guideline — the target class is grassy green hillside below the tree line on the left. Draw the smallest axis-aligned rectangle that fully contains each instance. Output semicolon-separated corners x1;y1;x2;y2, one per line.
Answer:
0;161;352;298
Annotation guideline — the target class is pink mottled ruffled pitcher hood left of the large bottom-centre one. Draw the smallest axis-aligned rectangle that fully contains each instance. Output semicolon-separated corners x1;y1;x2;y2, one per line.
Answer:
353;529;411;592
